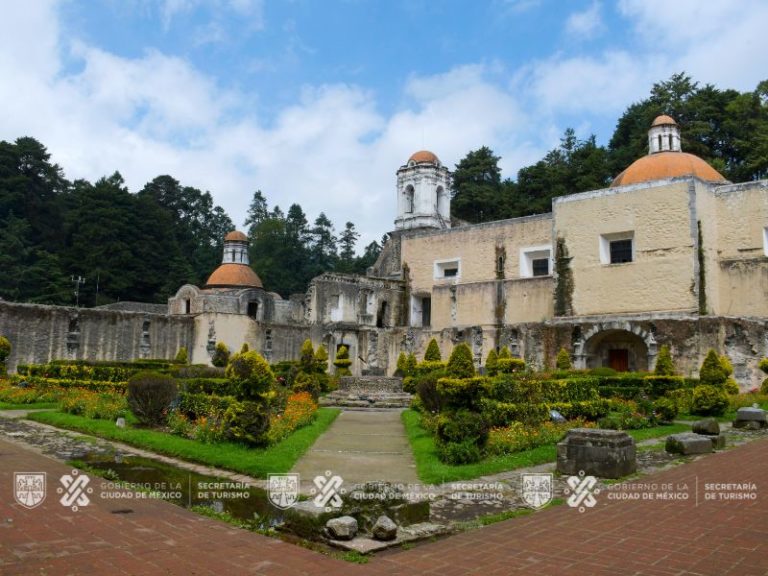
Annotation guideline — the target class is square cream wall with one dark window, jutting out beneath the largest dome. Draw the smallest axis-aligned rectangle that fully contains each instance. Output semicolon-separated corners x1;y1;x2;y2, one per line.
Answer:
553;179;698;316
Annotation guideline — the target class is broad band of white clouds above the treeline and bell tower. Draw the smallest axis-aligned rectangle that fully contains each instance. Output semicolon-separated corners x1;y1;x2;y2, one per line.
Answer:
0;0;768;255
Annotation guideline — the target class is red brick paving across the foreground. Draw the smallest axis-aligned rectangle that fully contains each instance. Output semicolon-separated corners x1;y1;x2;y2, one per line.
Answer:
0;439;768;576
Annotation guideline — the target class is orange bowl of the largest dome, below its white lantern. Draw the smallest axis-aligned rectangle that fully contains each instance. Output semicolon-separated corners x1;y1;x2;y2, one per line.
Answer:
611;151;727;186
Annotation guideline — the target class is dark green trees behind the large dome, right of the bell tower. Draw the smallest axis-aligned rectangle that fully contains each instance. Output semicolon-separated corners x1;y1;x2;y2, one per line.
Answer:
451;74;768;222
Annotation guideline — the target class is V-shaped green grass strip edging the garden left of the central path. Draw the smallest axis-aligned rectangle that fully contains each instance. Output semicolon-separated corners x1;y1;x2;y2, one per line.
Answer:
28;408;340;478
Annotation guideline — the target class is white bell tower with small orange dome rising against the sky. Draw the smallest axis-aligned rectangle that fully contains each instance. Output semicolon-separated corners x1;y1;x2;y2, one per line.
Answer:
395;150;451;230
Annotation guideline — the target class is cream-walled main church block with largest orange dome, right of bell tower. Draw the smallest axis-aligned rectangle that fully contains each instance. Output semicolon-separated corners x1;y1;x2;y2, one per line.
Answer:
358;116;768;387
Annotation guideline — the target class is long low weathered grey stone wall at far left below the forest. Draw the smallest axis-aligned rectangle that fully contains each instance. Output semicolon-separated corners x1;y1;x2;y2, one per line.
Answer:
0;302;194;371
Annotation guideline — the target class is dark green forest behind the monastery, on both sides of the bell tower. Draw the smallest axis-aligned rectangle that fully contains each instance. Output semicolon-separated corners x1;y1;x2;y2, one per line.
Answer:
0;74;768;306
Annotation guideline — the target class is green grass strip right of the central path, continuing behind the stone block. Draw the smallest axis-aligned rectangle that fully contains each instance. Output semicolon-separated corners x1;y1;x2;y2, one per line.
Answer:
402;410;690;484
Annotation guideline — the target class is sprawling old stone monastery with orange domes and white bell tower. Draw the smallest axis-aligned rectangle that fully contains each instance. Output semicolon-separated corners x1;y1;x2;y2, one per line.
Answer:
0;116;768;390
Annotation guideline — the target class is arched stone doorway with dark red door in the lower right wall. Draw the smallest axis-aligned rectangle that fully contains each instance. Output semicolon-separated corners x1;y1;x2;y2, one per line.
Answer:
585;329;649;372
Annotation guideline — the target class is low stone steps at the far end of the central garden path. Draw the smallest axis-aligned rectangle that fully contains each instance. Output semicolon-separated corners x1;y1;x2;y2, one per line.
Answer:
320;376;412;410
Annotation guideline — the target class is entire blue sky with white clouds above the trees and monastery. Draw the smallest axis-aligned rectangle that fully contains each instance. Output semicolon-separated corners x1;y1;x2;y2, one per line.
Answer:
0;0;768;244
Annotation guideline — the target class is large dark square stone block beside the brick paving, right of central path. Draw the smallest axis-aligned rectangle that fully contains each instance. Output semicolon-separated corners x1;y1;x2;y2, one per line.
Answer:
557;428;637;478
